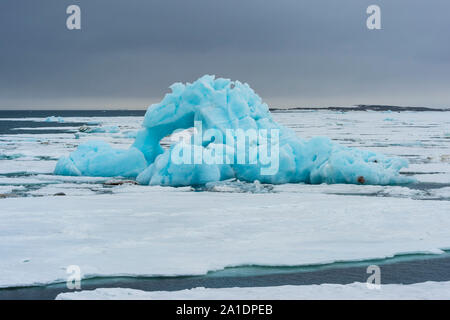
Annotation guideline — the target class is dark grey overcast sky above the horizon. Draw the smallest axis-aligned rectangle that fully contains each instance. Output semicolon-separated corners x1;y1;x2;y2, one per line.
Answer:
0;0;450;109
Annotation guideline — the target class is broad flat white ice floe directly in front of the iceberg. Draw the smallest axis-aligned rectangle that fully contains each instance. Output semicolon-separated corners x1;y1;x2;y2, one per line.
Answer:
0;186;450;287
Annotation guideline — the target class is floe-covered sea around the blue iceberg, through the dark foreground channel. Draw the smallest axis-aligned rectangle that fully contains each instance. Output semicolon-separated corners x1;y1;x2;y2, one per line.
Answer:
0;110;450;299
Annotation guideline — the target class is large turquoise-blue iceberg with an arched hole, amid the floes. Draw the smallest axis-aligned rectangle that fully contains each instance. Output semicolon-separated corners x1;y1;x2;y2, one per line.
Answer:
54;75;413;186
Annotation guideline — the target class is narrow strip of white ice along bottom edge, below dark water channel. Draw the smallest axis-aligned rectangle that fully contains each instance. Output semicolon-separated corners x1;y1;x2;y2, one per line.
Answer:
56;281;450;300
